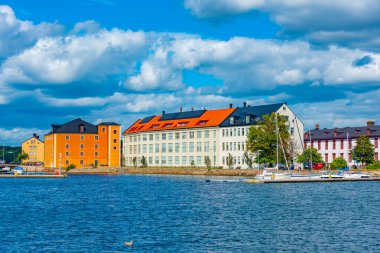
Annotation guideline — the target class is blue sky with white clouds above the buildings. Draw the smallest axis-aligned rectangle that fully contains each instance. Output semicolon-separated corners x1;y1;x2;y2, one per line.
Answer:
0;0;380;145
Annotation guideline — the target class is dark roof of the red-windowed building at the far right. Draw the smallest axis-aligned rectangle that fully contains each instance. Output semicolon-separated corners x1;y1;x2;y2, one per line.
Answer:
305;126;380;141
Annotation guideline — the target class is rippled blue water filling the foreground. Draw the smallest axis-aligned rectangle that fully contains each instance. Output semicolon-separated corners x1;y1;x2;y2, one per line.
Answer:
0;175;380;252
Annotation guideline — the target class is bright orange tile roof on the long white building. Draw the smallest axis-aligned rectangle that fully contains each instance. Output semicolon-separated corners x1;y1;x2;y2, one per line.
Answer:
123;108;236;135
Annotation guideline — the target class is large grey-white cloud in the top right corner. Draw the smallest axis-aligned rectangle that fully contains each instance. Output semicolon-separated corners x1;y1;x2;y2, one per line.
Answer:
184;0;380;51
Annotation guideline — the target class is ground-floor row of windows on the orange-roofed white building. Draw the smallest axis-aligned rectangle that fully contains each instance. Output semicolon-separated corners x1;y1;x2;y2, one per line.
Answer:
126;156;216;166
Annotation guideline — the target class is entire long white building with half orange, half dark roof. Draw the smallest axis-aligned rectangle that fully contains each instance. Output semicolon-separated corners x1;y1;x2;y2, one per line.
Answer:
123;103;303;168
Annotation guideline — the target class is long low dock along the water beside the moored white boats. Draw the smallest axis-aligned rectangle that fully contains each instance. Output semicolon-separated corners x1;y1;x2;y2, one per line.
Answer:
246;177;380;184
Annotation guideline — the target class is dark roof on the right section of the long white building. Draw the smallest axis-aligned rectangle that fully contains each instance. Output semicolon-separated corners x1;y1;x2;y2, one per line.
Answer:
220;103;285;127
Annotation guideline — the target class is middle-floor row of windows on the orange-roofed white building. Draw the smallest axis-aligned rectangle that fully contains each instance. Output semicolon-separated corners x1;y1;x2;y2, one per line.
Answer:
127;141;216;154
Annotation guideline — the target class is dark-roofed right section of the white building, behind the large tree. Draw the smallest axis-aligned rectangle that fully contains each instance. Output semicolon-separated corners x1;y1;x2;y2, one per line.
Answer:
219;103;304;168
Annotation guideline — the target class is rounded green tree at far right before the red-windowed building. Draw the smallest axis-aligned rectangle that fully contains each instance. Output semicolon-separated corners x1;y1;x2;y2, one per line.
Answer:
351;135;375;164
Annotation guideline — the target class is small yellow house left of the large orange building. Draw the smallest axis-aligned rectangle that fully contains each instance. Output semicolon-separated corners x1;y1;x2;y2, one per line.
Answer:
21;133;45;163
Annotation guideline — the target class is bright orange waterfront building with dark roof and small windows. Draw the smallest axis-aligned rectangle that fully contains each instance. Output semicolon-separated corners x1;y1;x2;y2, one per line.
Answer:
45;118;120;168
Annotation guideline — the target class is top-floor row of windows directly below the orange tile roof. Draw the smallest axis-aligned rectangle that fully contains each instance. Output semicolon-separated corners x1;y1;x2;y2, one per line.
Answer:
129;130;216;142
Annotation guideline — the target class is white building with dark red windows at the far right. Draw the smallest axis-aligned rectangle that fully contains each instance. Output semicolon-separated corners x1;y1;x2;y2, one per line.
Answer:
304;121;380;165
